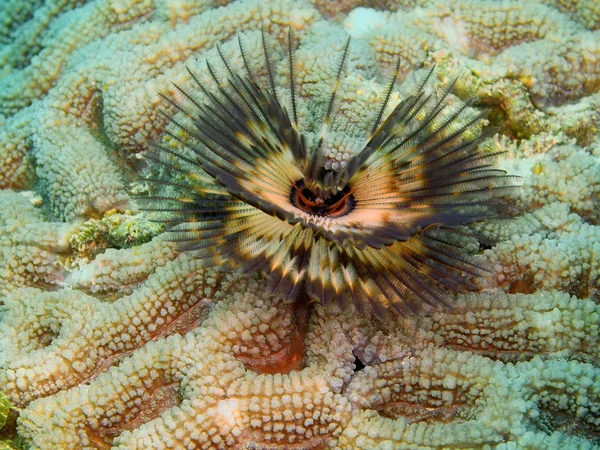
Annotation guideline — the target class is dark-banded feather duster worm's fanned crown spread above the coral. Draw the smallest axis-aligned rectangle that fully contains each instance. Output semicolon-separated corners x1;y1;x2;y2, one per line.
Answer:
139;32;510;316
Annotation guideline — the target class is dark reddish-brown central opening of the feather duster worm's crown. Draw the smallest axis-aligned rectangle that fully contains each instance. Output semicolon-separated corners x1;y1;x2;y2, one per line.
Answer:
290;180;356;217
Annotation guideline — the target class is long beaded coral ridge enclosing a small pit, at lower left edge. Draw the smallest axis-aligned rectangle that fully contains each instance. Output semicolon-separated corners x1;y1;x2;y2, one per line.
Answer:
0;253;220;406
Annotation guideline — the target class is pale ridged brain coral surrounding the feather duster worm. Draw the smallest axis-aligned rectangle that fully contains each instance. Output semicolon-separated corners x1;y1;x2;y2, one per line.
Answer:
0;0;600;450
